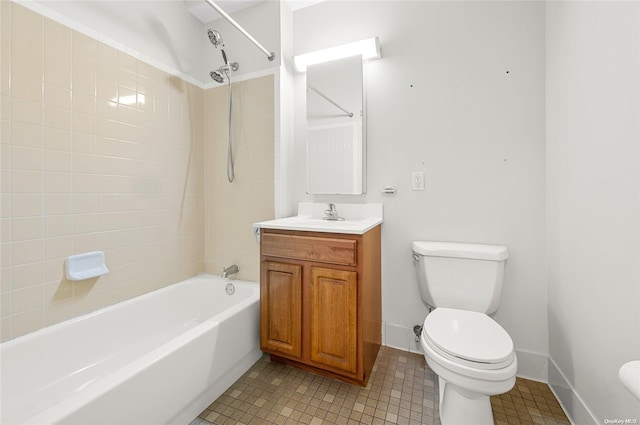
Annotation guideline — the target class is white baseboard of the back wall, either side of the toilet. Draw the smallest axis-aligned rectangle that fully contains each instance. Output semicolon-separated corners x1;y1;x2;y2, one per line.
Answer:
382;322;548;383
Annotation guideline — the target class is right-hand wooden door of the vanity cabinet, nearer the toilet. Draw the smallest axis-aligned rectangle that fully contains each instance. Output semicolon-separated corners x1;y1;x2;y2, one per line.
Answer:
309;267;358;373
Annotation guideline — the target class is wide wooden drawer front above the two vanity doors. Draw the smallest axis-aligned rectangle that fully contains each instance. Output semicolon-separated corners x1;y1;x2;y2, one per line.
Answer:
261;233;357;266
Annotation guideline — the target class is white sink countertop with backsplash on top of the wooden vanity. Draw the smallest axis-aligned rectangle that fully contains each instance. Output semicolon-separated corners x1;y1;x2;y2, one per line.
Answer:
254;203;382;235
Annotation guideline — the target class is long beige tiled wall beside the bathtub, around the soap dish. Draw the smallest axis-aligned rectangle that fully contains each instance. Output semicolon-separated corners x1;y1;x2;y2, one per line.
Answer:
0;1;210;341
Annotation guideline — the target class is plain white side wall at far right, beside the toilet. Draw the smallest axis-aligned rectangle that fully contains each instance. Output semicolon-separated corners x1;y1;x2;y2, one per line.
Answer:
546;2;640;424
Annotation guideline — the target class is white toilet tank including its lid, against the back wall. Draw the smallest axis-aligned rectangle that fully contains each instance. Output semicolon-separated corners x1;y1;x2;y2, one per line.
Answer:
411;241;508;314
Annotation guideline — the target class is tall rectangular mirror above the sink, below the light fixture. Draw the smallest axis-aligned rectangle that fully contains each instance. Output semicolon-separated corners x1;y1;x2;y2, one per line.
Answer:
306;56;366;195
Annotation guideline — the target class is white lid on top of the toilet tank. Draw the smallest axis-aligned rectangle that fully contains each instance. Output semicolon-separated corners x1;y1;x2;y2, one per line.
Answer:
411;241;509;261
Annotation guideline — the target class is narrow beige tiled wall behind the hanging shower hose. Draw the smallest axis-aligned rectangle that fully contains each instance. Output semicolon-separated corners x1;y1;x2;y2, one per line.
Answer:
204;75;275;282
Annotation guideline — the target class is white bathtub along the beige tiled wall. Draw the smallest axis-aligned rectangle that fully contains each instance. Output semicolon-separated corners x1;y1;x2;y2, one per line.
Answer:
0;275;261;425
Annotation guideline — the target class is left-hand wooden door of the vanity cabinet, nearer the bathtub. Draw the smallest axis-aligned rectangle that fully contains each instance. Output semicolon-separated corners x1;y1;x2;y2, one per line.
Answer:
260;261;302;358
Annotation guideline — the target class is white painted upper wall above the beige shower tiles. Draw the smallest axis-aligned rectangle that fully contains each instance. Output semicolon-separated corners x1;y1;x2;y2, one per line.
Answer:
29;0;282;88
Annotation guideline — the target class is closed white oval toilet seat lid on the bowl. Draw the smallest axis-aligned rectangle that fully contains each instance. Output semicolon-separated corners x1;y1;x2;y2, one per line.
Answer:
423;307;514;369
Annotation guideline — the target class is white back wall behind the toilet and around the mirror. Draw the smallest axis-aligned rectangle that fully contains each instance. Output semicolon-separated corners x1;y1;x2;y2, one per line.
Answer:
294;1;547;380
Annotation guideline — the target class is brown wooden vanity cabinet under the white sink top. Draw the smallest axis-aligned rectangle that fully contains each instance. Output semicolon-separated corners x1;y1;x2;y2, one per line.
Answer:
260;226;382;385
